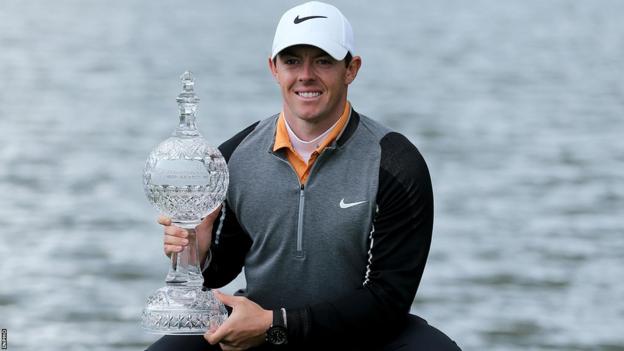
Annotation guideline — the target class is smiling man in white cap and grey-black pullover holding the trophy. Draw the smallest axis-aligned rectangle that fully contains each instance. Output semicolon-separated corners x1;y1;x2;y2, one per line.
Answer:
149;1;459;350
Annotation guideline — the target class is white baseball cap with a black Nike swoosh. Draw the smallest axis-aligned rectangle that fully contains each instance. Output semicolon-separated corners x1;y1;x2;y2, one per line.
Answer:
271;1;354;61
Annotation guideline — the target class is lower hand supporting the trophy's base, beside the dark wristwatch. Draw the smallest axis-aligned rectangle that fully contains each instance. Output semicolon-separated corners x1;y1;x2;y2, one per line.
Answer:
204;290;273;351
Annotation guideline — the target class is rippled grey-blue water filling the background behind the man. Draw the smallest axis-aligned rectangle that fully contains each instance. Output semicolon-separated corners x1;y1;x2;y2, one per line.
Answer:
0;0;624;350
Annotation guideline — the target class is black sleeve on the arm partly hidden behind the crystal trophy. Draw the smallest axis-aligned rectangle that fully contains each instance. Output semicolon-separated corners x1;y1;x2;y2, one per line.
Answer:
203;122;259;288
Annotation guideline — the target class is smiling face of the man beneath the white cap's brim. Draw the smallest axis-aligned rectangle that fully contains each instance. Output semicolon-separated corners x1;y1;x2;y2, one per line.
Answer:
269;45;361;128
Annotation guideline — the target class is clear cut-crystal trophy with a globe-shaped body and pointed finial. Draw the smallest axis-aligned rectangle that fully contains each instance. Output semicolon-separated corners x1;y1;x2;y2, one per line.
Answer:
141;71;229;335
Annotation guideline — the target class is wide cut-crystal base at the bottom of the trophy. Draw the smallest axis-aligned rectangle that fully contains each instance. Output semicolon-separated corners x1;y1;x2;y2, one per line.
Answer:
141;285;228;335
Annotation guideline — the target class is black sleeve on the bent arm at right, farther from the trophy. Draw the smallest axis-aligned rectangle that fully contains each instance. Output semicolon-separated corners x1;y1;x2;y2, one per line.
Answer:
288;133;433;346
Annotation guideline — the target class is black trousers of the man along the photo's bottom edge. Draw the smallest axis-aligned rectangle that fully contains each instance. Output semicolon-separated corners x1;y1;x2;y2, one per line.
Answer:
146;315;461;351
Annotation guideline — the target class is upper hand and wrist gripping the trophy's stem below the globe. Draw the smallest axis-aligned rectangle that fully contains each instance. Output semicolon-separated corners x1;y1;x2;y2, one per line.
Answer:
158;206;221;262
